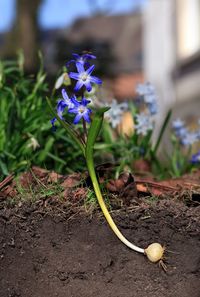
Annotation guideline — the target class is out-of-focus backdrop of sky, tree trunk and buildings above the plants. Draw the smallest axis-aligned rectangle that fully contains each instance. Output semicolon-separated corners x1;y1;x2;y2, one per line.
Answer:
0;0;200;125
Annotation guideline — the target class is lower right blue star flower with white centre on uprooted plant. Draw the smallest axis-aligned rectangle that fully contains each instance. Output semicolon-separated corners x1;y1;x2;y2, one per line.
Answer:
68;97;92;124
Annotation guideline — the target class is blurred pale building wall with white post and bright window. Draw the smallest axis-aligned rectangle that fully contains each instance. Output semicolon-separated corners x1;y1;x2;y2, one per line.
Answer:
143;0;200;139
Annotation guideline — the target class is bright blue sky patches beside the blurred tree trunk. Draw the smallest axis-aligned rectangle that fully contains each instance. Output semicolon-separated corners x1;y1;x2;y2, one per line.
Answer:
0;0;148;32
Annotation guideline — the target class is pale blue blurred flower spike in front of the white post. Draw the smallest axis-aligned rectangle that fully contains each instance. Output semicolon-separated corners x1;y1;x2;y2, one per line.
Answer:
135;82;158;136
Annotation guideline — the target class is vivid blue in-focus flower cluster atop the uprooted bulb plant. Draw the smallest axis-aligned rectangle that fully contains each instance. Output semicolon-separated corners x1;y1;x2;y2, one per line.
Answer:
51;54;102;129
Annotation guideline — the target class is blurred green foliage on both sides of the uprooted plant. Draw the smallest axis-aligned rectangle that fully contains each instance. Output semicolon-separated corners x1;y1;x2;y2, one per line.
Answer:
0;53;199;180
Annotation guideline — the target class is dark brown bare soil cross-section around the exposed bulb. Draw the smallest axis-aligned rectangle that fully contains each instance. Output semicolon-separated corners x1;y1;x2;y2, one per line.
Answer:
0;199;200;297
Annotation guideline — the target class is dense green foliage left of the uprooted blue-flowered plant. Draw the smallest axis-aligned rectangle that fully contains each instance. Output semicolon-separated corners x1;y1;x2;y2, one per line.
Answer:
0;54;84;179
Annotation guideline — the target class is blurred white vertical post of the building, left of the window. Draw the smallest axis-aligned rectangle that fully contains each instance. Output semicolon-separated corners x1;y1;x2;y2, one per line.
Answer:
143;0;176;138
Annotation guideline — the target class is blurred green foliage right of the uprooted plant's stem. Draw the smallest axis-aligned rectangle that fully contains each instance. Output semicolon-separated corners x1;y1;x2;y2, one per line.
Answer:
95;103;200;180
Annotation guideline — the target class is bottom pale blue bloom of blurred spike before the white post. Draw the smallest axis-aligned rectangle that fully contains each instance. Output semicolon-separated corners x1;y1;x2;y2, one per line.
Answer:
135;113;153;136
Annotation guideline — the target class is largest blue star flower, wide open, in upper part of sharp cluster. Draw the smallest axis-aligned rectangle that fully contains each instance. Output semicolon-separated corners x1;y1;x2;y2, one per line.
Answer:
69;63;102;92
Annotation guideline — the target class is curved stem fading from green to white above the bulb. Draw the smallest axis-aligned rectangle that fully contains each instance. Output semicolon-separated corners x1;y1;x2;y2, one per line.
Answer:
86;154;144;254
